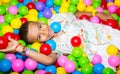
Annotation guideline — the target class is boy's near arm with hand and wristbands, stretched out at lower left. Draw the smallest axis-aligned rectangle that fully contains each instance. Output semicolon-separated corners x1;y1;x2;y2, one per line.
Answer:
0;39;57;65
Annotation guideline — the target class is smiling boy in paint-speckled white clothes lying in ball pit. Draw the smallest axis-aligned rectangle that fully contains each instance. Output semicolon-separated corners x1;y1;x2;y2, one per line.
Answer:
0;12;120;72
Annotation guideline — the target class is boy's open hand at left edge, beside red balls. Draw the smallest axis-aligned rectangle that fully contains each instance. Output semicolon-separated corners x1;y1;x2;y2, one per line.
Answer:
0;39;19;52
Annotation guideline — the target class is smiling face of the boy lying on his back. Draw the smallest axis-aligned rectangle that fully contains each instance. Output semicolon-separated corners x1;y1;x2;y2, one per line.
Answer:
27;22;54;42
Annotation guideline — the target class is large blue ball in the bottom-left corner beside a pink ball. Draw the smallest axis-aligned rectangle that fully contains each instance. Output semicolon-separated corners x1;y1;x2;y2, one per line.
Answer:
0;59;12;72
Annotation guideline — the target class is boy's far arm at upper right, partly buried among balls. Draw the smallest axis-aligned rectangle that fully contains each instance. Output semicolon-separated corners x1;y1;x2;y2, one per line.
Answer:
75;12;114;20
